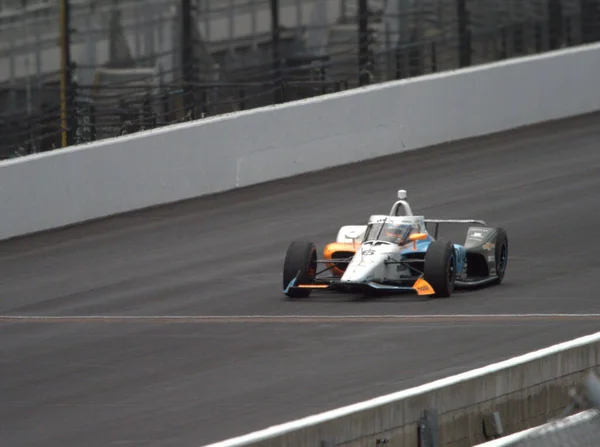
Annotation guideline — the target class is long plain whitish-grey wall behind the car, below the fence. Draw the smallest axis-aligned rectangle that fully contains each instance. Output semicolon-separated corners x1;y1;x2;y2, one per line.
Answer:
0;44;600;239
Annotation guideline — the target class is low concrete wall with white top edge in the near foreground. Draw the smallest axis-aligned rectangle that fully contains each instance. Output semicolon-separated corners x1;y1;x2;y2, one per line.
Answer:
208;332;600;447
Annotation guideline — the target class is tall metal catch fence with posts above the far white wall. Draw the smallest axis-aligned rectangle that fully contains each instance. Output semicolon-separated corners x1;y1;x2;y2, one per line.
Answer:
0;0;600;158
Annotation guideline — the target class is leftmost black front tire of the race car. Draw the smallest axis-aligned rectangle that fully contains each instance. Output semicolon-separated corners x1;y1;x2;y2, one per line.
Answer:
283;241;317;298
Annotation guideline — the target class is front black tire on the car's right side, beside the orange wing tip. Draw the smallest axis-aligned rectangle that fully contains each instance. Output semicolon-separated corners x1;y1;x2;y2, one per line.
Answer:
423;240;456;298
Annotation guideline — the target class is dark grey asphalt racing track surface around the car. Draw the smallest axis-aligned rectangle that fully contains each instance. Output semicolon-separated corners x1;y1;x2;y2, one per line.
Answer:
0;115;600;447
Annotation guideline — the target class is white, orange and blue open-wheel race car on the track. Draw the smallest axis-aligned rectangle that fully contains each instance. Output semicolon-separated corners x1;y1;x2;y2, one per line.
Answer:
283;190;508;298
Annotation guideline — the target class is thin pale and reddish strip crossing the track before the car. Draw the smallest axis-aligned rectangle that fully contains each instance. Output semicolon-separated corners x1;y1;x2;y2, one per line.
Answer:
0;313;600;323
